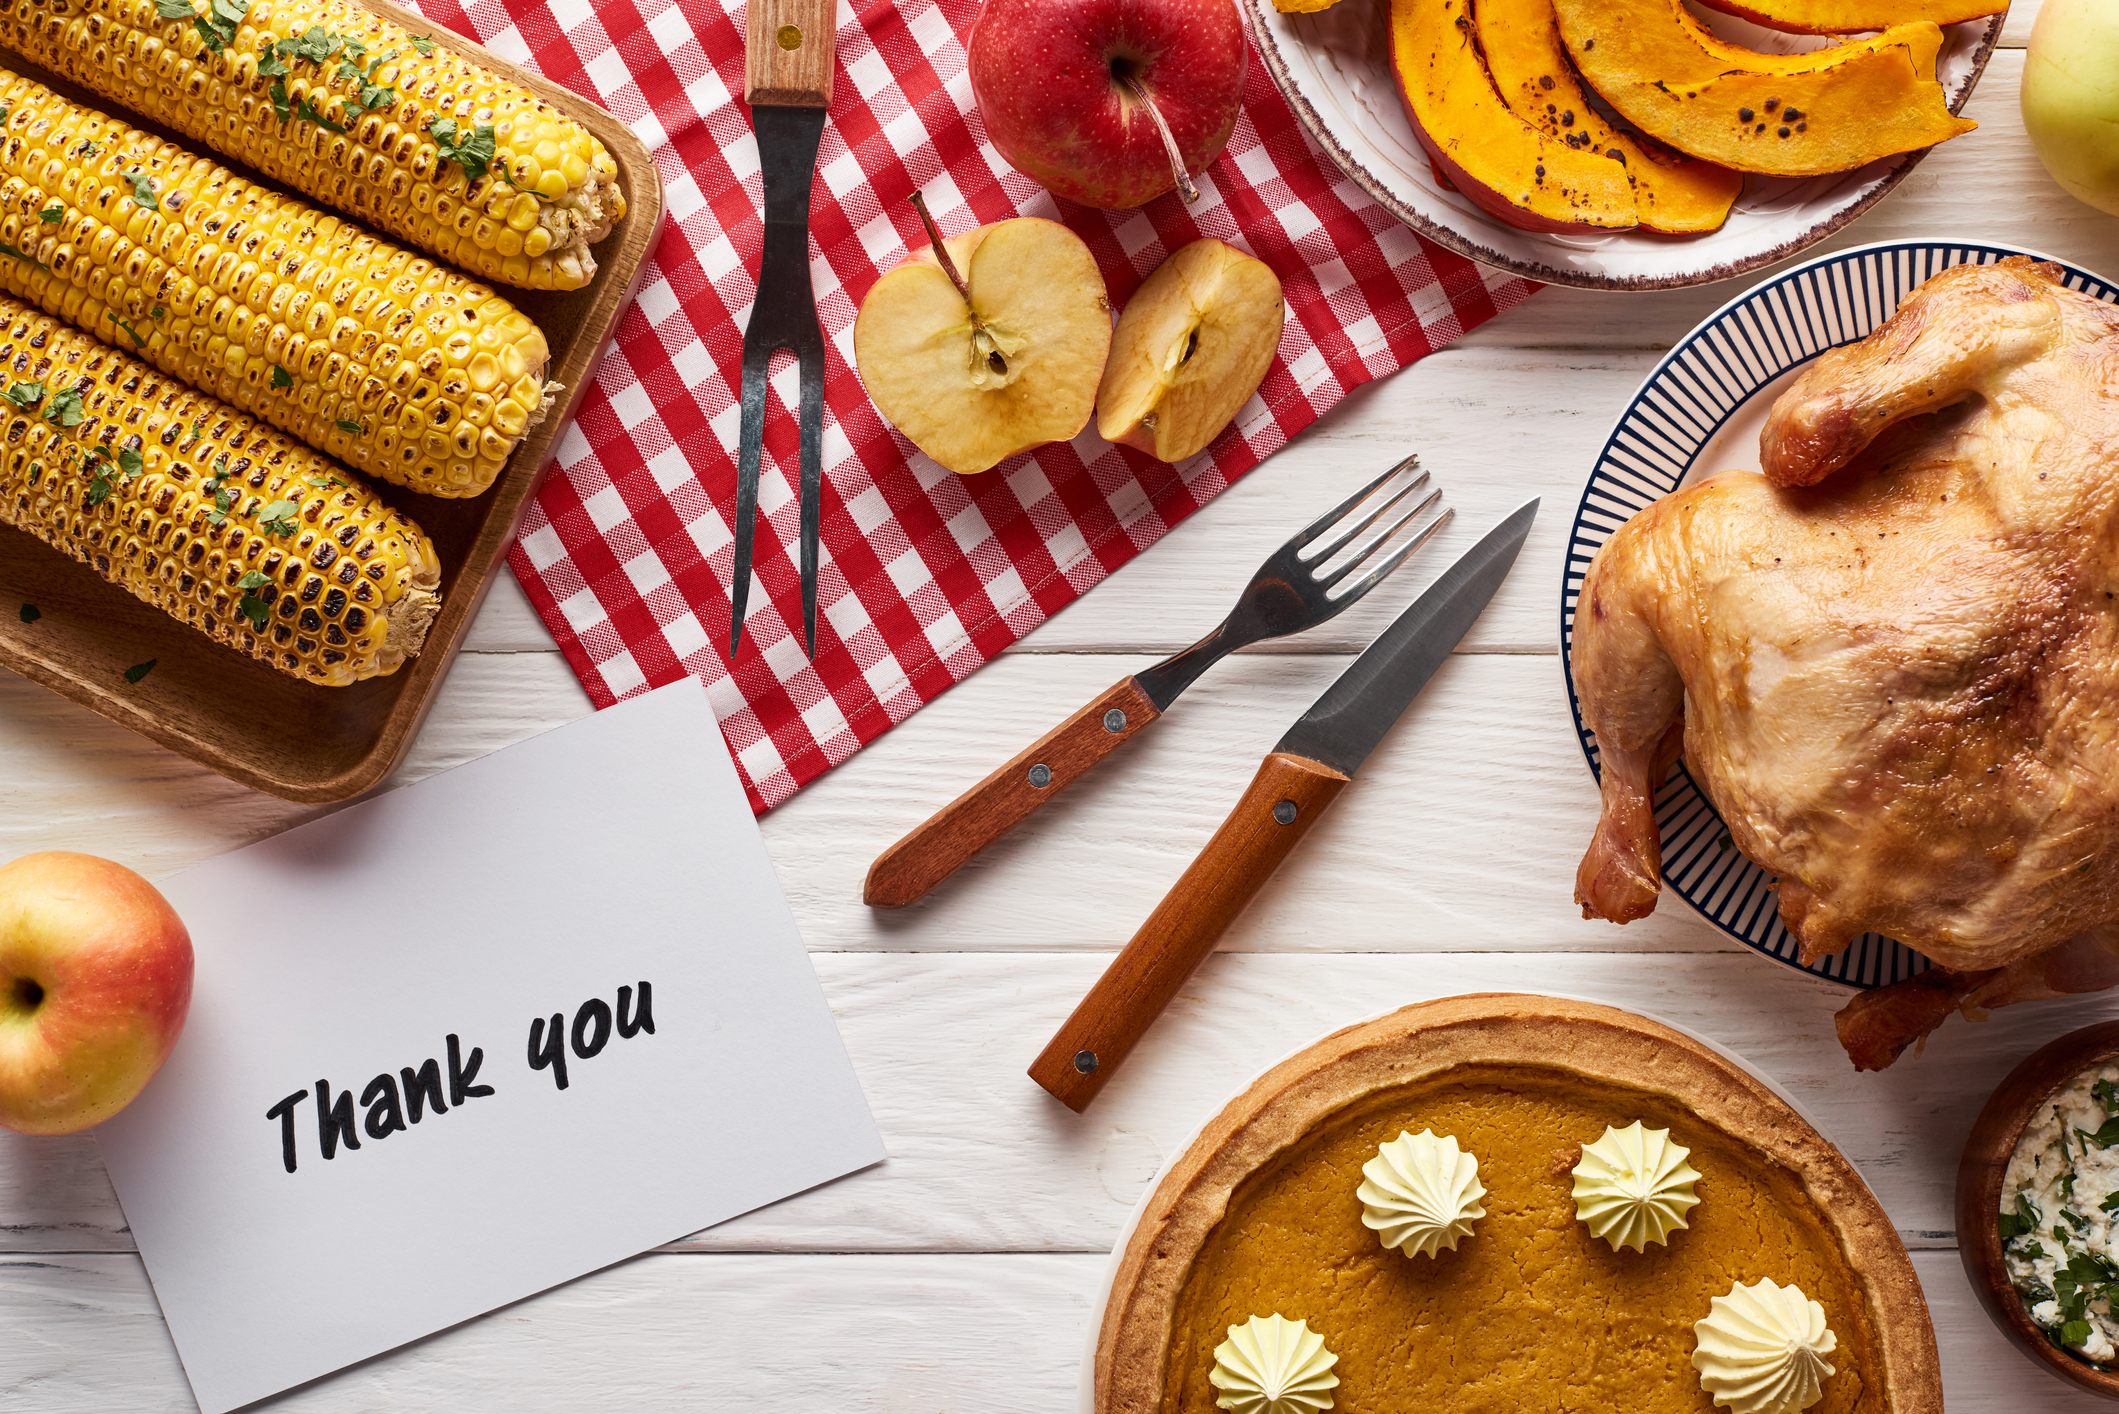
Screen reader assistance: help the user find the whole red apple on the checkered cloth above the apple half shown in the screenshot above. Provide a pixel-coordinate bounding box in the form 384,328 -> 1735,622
971,0 -> 1250,210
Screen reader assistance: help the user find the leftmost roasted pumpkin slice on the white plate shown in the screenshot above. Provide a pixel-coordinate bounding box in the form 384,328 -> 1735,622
1390,0 -> 1638,231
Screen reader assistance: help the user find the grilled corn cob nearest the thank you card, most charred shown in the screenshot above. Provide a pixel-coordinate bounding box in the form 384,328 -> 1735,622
0,297 -> 441,687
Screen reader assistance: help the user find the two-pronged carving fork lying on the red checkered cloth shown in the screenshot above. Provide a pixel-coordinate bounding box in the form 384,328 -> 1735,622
729,0 -> 833,659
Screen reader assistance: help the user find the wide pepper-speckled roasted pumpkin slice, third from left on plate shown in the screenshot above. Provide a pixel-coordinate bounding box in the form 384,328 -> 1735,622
1553,0 -> 1977,176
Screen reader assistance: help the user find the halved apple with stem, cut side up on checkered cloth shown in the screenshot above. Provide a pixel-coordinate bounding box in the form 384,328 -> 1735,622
854,197 -> 1110,475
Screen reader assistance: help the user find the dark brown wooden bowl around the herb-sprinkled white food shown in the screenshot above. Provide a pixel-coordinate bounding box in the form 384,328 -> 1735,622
1958,1022 -> 2119,1399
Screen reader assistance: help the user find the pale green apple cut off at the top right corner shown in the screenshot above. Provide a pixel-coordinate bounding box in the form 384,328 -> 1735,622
2022,0 -> 2119,216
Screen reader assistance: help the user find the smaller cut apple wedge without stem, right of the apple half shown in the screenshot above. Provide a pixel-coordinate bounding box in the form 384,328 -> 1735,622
1096,240 -> 1282,462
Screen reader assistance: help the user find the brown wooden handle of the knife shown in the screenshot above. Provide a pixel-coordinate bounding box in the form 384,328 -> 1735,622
1030,750 -> 1348,1113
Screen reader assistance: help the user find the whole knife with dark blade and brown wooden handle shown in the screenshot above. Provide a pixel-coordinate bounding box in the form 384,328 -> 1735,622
1030,498 -> 1538,1113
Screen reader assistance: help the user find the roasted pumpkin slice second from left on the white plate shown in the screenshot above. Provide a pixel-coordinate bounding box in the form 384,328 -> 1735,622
1473,0 -> 1744,233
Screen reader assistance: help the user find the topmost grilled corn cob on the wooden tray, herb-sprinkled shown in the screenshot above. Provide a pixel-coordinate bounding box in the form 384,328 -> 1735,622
0,0 -> 625,290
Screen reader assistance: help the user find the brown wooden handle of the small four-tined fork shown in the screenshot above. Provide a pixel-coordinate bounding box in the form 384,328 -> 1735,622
860,676 -> 1161,907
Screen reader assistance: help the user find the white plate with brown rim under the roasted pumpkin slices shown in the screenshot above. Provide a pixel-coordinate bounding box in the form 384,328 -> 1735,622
1244,0 -> 2007,290
